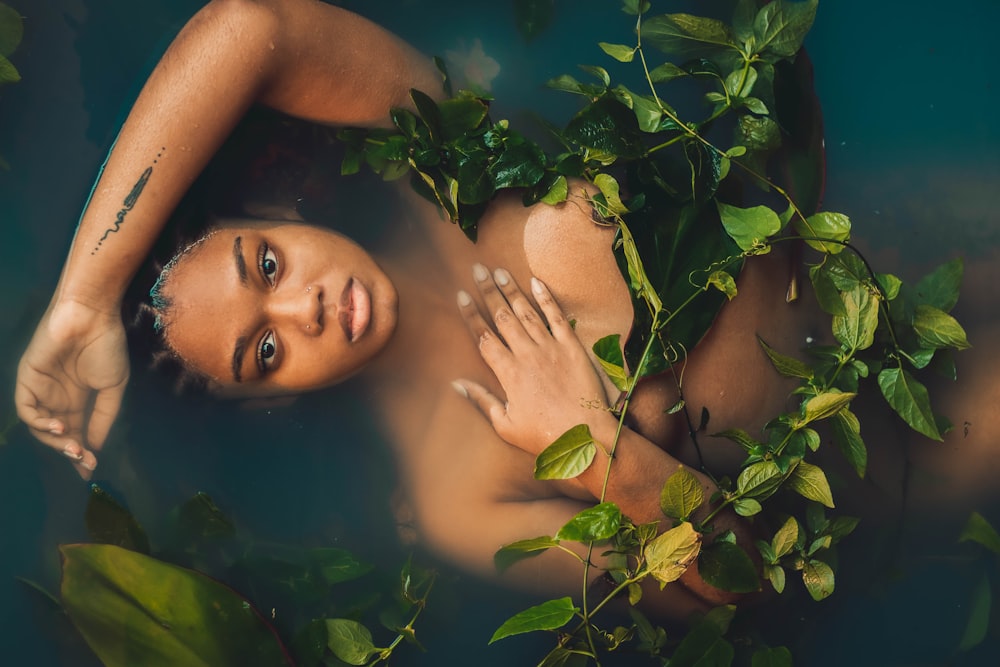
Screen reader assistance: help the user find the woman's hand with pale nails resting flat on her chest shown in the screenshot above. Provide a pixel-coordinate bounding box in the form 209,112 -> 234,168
455,264 -> 614,455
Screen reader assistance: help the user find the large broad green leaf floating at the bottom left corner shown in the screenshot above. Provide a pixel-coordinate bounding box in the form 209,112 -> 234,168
59,544 -> 291,667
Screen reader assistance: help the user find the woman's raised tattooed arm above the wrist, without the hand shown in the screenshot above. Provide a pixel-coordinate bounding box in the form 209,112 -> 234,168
55,0 -> 440,314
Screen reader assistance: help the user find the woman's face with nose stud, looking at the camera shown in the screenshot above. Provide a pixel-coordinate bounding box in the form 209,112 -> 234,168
160,220 -> 396,396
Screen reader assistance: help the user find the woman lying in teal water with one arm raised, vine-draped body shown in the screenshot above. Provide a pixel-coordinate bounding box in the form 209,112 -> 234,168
16,0 -> 828,615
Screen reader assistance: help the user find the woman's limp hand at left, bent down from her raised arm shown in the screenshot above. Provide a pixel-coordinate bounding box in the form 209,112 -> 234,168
14,302 -> 129,479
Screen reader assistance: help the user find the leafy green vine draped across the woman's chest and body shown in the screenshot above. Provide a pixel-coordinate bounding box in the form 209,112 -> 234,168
339,0 -> 968,665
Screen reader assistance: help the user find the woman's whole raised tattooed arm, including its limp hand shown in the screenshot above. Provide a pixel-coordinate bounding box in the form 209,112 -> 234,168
15,0 -> 441,477
